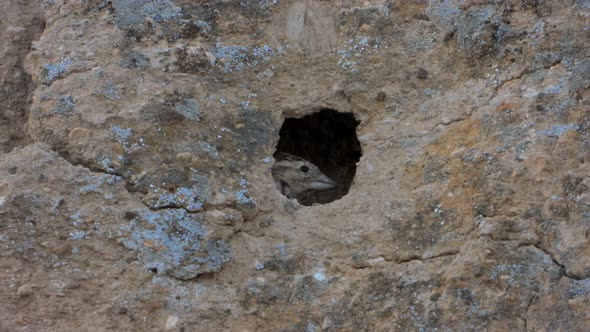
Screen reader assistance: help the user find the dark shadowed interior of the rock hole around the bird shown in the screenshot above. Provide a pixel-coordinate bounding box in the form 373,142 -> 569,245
274,109 -> 362,206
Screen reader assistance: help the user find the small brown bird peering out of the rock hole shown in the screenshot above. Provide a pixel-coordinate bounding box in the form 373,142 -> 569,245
271,152 -> 338,199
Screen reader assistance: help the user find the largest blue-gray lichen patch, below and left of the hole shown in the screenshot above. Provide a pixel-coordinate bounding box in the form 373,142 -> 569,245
121,209 -> 232,280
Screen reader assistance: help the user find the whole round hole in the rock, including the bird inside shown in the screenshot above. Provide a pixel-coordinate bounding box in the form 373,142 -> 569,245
272,109 -> 362,206
